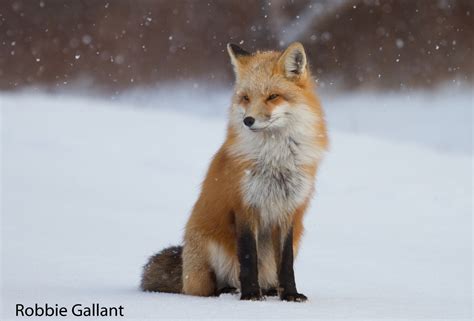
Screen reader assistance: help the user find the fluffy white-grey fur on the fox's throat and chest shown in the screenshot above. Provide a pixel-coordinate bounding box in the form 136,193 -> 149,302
230,106 -> 323,227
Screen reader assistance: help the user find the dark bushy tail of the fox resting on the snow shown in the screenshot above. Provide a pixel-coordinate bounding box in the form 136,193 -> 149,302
140,246 -> 183,293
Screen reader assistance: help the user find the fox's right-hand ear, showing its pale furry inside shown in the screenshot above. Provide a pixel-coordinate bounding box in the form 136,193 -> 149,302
278,42 -> 307,79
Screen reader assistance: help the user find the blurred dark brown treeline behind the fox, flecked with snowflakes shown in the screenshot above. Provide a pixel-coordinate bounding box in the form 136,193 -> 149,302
0,0 -> 474,91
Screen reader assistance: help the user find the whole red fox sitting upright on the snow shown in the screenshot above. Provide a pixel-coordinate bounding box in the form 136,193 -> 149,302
141,43 -> 328,302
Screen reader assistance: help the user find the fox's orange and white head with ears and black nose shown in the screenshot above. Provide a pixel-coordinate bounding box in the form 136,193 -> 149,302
227,42 -> 322,135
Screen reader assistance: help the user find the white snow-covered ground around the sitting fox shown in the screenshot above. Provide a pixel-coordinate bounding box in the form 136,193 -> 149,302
0,86 -> 473,320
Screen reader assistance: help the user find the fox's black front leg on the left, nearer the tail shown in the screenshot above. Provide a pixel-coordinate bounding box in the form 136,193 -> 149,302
238,229 -> 262,300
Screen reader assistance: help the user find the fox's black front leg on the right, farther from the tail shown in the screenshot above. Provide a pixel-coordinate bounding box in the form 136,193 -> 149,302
278,224 -> 308,302
